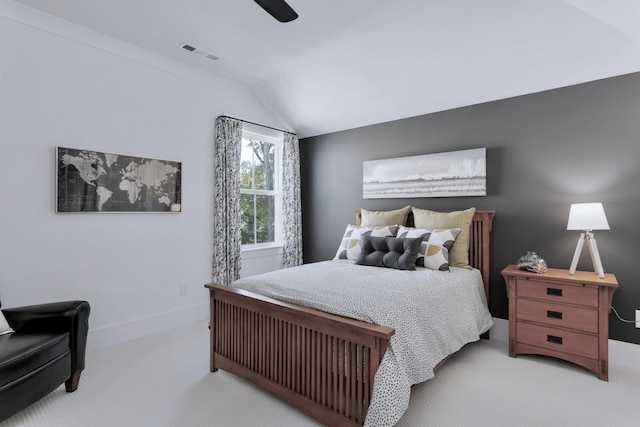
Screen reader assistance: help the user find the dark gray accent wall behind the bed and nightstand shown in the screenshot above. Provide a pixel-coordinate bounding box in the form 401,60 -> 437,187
300,73 -> 640,344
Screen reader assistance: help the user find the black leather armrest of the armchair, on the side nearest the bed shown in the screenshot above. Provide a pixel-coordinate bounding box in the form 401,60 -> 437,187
2,301 -> 91,373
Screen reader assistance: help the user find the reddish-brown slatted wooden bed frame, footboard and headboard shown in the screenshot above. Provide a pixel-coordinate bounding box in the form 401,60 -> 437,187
205,210 -> 494,426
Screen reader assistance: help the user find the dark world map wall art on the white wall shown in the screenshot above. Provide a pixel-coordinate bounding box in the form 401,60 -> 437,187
56,147 -> 182,212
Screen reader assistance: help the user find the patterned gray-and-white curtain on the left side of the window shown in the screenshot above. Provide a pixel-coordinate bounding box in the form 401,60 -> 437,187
211,117 -> 242,285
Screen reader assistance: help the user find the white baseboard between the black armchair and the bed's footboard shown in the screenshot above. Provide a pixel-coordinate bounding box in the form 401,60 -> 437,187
87,303 -> 209,352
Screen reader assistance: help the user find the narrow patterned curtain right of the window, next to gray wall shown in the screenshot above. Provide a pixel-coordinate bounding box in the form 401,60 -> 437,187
282,132 -> 302,268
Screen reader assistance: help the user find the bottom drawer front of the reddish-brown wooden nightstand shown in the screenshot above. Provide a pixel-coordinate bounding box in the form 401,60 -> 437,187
516,322 -> 598,359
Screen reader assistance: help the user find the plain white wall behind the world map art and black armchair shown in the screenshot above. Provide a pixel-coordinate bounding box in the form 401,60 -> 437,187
0,1 -> 279,350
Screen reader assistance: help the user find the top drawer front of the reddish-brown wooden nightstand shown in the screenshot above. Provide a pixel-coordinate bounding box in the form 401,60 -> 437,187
516,277 -> 598,307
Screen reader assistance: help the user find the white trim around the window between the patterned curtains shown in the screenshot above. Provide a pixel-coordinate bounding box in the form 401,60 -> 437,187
240,124 -> 284,251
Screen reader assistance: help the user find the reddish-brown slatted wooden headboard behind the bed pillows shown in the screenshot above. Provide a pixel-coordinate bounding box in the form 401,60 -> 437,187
354,210 -> 496,301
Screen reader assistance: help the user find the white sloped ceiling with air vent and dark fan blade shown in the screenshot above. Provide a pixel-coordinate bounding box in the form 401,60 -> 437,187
15,0 -> 640,137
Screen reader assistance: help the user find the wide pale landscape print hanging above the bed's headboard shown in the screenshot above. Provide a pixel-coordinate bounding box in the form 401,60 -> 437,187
362,148 -> 487,199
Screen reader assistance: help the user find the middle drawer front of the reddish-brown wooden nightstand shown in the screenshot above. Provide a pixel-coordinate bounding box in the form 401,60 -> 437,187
516,299 -> 598,334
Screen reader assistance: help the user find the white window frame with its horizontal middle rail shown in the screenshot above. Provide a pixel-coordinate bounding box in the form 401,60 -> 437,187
239,125 -> 284,252
